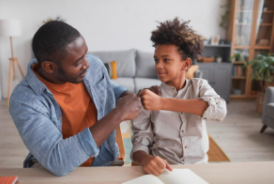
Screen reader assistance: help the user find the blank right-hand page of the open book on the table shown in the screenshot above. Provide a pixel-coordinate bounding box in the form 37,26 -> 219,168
158,169 -> 208,184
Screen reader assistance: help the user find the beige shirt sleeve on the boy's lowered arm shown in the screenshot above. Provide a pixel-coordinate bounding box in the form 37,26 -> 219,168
130,108 -> 154,161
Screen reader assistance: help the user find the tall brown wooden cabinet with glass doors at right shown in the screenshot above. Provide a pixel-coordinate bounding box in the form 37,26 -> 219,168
227,0 -> 274,99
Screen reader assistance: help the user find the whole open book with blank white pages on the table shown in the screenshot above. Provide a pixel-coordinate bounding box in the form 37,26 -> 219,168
122,169 -> 208,184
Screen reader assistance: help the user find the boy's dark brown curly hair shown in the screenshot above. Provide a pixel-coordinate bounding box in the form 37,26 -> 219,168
150,17 -> 204,61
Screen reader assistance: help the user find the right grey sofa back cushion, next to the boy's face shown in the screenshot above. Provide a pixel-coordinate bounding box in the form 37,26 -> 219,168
136,50 -> 158,79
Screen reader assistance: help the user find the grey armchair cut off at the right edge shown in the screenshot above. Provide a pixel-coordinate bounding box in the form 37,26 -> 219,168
261,87 -> 274,133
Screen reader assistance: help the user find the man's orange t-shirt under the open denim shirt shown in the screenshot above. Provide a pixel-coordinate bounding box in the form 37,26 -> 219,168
32,63 -> 97,166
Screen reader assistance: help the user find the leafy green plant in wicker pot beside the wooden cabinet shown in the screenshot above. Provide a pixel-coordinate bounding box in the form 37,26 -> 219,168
245,54 -> 274,114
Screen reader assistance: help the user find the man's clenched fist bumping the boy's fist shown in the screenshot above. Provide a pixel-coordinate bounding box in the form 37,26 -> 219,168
116,93 -> 142,121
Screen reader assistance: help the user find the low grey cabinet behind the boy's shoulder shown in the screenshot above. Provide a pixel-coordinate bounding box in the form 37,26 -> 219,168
198,63 -> 232,102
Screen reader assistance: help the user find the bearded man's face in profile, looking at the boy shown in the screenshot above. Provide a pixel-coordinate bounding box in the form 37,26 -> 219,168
57,36 -> 89,83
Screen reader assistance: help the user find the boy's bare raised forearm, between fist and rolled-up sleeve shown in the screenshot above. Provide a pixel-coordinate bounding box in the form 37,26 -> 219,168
161,98 -> 208,116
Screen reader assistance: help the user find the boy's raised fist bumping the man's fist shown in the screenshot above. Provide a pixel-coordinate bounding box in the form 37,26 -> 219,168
138,89 -> 163,111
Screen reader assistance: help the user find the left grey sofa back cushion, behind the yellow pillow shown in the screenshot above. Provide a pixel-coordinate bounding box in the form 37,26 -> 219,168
90,49 -> 136,78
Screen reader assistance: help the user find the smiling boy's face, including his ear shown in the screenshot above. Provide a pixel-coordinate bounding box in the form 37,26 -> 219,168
154,45 -> 191,83
